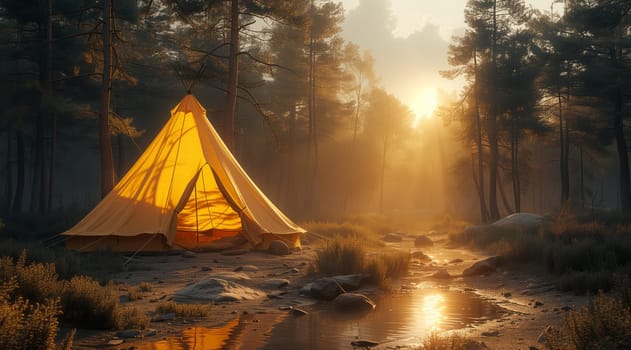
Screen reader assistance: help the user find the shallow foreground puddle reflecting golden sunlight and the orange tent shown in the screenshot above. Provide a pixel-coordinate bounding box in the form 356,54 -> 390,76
137,290 -> 502,350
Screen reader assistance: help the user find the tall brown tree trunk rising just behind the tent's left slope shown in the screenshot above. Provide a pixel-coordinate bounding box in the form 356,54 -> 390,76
99,0 -> 114,198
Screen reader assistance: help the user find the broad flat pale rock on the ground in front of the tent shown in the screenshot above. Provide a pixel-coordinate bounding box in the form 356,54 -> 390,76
173,278 -> 265,303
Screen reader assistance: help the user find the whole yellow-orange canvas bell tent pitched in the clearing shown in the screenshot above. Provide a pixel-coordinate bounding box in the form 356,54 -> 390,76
62,94 -> 305,251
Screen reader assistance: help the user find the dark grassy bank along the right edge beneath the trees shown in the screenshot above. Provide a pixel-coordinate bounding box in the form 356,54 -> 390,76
450,212 -> 631,293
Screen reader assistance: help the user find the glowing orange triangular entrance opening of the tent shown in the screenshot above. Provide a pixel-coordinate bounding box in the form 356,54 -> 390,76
175,164 -> 243,247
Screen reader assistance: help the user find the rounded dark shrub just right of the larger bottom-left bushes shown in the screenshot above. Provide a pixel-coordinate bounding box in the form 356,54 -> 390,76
62,276 -> 123,329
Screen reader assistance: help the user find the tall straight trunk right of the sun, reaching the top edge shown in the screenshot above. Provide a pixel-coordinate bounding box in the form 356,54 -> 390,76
487,0 -> 500,221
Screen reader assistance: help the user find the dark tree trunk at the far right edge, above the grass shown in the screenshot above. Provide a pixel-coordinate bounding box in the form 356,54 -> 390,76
613,87 -> 631,212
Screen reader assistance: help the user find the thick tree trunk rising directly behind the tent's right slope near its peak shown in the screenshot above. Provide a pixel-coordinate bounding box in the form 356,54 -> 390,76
223,0 -> 240,152
